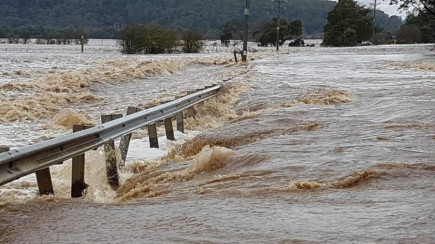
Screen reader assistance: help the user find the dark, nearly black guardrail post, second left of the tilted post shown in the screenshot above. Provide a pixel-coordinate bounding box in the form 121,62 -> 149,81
71,125 -> 89,197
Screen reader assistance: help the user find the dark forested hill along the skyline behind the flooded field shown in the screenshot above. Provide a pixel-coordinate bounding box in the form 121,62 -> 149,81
0,0 -> 336,36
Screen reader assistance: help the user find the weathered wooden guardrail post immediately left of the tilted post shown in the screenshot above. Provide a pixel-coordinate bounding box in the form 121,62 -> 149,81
101,114 -> 122,190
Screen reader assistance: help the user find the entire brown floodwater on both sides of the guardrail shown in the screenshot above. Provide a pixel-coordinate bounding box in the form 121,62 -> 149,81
0,41 -> 435,243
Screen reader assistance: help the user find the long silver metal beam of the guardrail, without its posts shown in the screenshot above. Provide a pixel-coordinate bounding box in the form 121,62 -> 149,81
0,85 -> 220,185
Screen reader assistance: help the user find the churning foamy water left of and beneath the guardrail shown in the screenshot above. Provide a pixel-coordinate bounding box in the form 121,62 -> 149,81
0,40 -> 268,204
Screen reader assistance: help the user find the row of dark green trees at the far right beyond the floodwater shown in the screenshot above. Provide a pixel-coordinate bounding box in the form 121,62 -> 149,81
322,0 -> 435,46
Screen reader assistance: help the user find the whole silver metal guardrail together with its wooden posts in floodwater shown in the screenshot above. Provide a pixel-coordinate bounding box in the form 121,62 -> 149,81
0,85 -> 220,197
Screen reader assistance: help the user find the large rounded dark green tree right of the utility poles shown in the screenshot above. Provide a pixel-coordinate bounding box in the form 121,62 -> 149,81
322,0 -> 373,46
